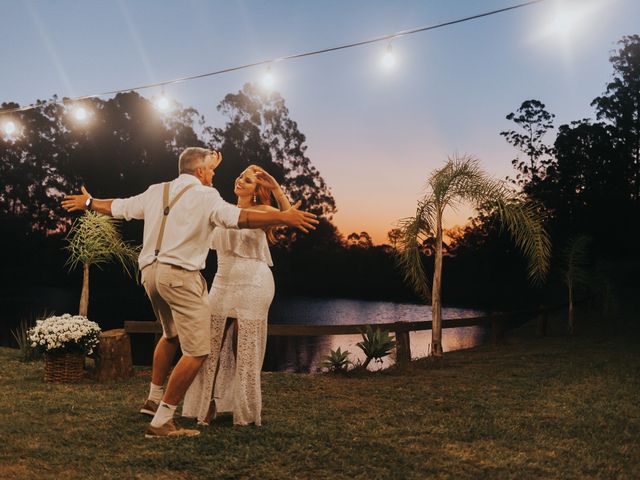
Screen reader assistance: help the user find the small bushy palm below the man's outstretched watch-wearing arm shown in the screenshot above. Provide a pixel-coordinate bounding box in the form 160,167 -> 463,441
65,211 -> 140,317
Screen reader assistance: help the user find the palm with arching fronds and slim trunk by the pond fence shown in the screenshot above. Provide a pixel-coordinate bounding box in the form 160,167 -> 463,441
396,155 -> 551,356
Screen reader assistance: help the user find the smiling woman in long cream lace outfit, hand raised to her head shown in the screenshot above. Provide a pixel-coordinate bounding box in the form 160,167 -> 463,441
182,165 -> 291,426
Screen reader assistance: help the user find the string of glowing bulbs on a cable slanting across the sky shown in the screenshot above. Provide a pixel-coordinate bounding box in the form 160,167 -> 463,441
0,0 -> 545,122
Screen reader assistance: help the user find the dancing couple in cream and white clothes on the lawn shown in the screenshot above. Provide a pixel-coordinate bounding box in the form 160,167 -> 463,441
62,147 -> 318,438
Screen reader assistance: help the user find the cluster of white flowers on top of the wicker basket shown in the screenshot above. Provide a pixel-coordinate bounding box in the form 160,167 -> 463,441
28,313 -> 100,355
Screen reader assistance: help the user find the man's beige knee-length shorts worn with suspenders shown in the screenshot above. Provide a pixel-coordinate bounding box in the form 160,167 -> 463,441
142,261 -> 211,357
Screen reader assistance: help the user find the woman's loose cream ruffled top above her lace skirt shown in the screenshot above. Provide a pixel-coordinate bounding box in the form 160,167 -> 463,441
211,227 -> 273,267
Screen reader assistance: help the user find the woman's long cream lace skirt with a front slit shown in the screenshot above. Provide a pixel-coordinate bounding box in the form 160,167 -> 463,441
182,255 -> 275,425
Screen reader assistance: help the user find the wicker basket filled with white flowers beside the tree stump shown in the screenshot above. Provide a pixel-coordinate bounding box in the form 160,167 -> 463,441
28,313 -> 100,383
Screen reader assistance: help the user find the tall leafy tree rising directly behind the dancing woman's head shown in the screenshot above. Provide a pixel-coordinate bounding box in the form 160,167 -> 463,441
209,83 -> 336,220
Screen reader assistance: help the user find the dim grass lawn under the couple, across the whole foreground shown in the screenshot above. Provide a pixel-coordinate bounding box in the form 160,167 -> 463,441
0,316 -> 640,480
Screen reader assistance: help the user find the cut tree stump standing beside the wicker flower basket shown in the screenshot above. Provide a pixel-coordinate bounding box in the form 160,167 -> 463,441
95,328 -> 133,382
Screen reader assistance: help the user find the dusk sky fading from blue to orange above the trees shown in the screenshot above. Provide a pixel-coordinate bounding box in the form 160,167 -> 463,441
0,0 -> 640,243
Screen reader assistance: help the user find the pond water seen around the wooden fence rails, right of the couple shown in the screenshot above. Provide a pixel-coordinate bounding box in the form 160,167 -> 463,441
263,298 -> 488,373
